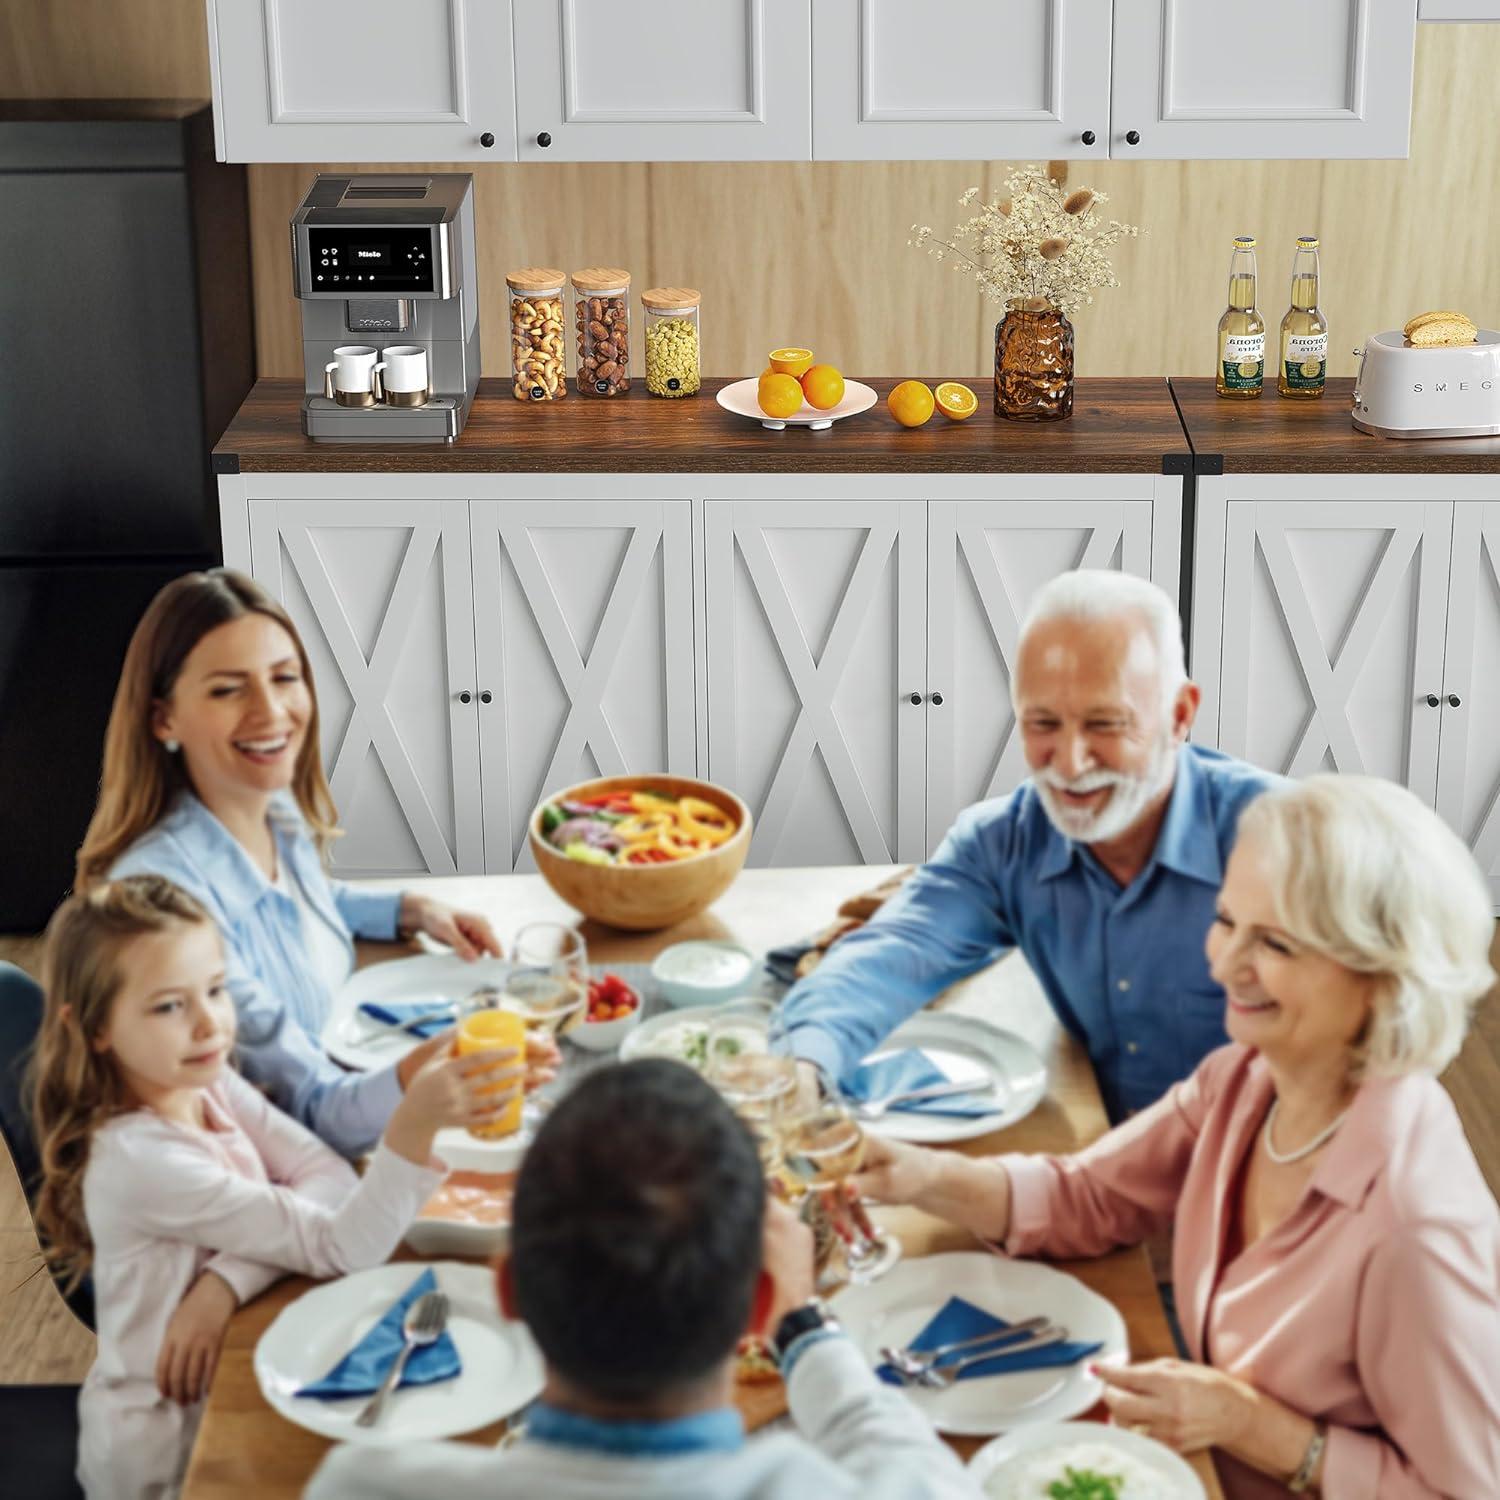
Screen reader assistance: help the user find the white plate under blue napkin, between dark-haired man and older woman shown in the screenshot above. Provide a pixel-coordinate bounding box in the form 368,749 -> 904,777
834,1251 -> 1130,1437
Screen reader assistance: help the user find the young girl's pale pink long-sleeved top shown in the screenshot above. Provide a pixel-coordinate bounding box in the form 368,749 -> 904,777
78,1073 -> 443,1500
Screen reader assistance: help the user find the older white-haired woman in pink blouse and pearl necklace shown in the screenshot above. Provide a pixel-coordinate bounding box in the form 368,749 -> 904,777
861,776 -> 1500,1500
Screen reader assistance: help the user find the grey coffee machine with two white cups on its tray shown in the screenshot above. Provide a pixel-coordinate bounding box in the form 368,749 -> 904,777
291,173 -> 479,443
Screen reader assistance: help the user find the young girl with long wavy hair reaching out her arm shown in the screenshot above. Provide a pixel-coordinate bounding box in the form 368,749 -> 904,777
35,876 -> 521,1500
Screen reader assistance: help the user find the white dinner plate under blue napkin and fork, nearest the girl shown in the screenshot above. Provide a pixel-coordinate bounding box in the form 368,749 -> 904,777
255,1260 -> 543,1443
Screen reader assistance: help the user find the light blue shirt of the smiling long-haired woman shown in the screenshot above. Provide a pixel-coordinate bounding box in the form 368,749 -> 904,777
110,792 -> 401,1155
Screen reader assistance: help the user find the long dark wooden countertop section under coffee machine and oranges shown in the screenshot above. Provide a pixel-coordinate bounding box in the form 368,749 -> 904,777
213,375 -> 1190,474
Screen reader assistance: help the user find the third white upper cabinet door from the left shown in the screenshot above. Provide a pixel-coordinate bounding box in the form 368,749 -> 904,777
813,0 -> 1110,161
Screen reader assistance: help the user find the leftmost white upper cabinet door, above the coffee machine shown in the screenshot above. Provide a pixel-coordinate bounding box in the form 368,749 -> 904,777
209,0 -> 516,162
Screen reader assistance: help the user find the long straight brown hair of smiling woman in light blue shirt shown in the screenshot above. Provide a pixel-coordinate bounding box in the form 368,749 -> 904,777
74,567 -> 339,891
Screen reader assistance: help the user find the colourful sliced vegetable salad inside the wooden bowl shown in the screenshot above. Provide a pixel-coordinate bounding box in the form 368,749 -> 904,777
542,789 -> 740,866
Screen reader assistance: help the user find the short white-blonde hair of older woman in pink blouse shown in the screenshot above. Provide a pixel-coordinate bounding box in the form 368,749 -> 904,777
1238,776 -> 1496,1080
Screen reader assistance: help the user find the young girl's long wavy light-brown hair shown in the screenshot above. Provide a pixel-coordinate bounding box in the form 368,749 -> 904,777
30,875 -> 213,1289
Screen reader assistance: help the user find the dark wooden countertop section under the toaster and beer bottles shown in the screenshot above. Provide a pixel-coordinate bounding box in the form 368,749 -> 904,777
1172,375 -> 1500,474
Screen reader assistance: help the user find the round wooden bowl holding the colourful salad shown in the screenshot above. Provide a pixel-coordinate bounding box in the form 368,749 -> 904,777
530,776 -> 752,932
